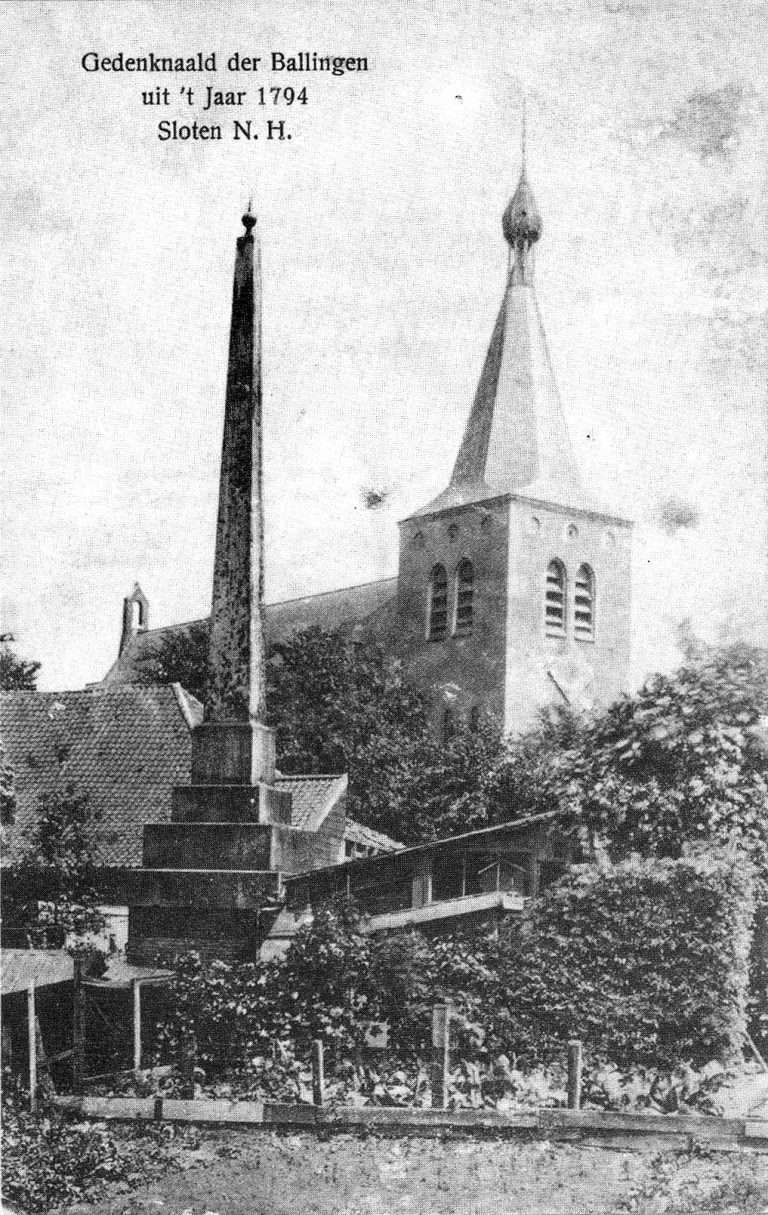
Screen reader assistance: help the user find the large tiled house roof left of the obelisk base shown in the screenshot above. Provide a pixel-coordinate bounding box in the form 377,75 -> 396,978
0,684 -> 202,865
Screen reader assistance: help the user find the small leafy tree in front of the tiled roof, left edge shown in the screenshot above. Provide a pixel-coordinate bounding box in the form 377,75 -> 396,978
2,784 -> 103,948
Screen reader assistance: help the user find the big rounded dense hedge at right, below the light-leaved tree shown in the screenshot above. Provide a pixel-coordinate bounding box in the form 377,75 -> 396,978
498,852 -> 753,1069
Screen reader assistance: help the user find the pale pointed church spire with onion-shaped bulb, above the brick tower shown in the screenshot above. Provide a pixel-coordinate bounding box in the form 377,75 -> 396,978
425,126 -> 587,510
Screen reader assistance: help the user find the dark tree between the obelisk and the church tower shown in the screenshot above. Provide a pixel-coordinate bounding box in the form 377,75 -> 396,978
267,628 -> 501,843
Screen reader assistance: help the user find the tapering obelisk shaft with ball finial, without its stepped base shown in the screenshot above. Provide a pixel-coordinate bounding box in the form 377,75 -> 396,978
205,205 -> 266,724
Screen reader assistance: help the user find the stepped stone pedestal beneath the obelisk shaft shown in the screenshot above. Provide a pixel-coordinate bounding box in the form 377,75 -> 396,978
128,722 -> 301,965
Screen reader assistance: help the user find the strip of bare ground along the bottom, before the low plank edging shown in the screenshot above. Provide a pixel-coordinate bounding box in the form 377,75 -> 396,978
44,1126 -> 768,1215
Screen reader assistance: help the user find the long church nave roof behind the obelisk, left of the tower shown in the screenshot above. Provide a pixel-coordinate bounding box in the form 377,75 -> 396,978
103,578 -> 397,685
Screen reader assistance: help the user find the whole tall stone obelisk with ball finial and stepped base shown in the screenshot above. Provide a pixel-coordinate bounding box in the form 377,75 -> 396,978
128,213 -> 294,962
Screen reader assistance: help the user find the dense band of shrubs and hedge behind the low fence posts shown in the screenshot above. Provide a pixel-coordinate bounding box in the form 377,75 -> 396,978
160,855 -> 752,1103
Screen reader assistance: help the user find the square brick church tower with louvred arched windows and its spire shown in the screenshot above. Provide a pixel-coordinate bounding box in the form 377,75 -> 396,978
397,151 -> 632,734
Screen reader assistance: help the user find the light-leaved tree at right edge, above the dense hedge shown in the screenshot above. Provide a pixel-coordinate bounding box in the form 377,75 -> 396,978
490,645 -> 768,881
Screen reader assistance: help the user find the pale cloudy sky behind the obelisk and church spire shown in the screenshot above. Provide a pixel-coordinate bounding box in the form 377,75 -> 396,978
0,0 -> 768,689
